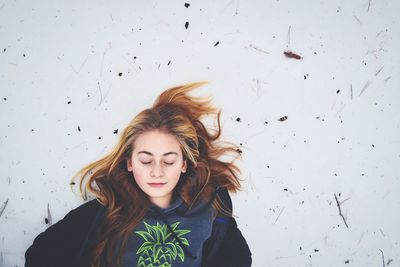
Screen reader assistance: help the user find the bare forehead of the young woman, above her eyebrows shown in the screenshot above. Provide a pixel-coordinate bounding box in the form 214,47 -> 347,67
133,130 -> 181,155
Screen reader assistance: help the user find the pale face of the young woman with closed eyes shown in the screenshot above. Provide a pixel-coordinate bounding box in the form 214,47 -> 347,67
127,130 -> 186,208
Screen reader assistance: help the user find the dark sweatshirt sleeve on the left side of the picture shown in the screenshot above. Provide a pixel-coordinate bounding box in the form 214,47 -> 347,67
25,200 -> 99,267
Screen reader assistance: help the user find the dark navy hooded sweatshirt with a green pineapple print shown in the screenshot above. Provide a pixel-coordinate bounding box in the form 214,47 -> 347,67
25,189 -> 252,267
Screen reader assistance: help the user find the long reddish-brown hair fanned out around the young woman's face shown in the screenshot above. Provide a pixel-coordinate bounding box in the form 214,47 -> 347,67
72,82 -> 240,267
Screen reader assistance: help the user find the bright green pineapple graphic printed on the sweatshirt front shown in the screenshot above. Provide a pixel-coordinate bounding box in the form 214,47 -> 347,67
135,222 -> 191,267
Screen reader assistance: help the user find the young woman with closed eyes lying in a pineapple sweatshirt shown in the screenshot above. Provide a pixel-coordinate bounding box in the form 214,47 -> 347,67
25,83 -> 252,267
